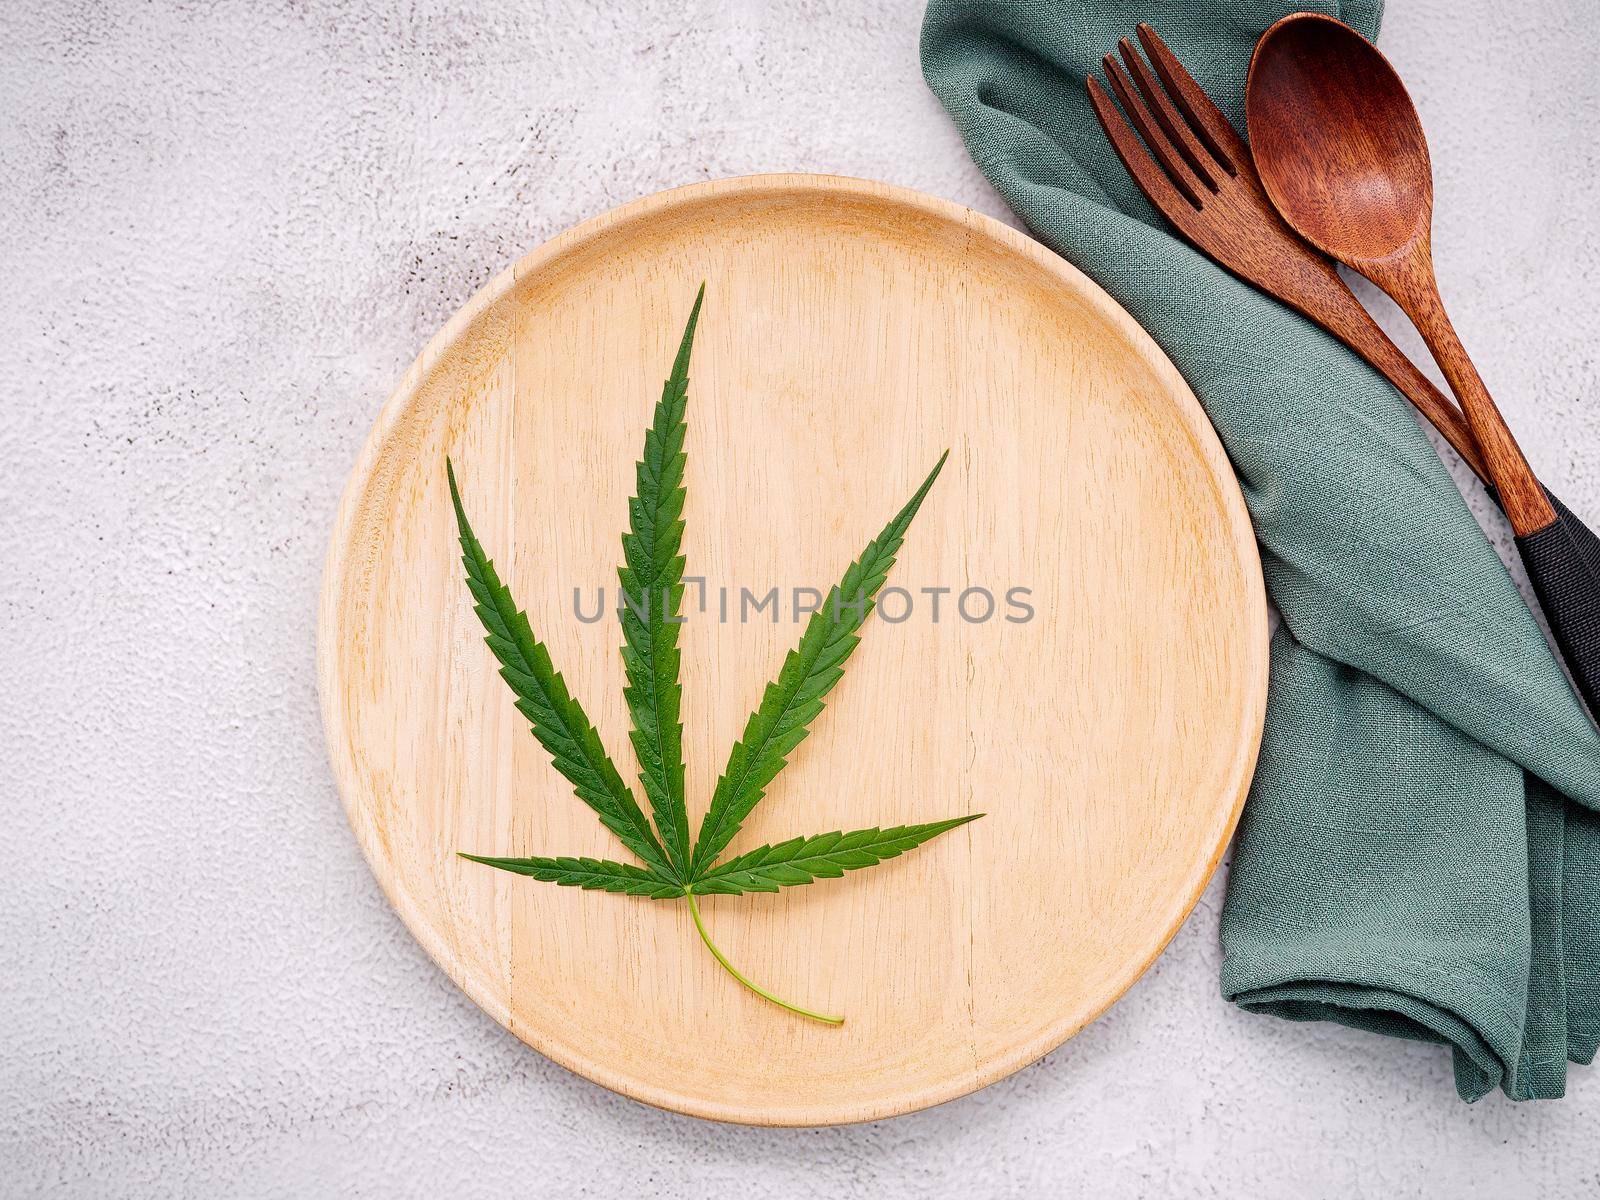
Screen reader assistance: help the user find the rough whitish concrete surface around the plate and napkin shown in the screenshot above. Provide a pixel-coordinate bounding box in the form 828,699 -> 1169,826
0,0 -> 1600,1200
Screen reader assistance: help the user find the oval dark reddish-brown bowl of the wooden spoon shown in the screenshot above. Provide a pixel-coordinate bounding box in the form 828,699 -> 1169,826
1245,13 -> 1434,266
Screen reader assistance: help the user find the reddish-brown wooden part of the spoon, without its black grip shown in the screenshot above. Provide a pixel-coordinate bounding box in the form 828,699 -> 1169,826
1245,13 -> 1555,536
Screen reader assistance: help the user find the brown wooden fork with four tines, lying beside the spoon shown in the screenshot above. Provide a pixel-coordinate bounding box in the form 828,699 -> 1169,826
1088,24 -> 1486,478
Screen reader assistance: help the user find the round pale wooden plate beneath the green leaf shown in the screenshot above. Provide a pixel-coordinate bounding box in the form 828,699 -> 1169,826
318,176 -> 1267,1125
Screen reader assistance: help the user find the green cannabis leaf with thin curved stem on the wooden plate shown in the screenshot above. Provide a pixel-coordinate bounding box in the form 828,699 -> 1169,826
445,285 -> 982,1026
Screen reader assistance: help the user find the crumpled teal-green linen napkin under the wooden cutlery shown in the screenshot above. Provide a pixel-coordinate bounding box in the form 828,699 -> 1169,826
922,0 -> 1600,1099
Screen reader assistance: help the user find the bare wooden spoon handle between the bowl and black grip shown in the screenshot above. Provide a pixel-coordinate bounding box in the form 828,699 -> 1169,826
1366,238 -> 1555,538
